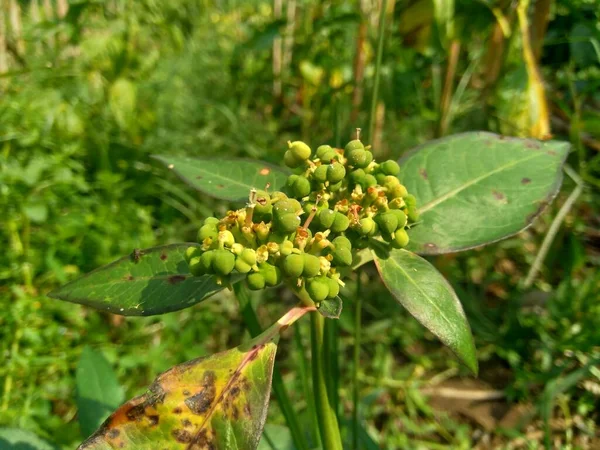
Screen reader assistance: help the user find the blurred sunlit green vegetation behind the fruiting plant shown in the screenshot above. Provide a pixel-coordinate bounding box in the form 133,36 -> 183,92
0,0 -> 600,449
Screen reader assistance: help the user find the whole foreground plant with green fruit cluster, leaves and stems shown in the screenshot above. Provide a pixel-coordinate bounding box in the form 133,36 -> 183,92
51,132 -> 569,450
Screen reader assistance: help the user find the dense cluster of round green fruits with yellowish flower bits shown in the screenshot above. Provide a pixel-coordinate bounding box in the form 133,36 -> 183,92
186,134 -> 418,303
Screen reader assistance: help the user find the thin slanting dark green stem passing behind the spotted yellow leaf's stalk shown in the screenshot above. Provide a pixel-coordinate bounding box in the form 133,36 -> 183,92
233,283 -> 309,450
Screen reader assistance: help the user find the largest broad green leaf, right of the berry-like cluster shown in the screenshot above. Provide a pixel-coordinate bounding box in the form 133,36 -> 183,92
400,132 -> 569,255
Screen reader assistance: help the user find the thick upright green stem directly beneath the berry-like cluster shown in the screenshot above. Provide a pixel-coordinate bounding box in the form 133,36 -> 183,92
310,312 -> 342,450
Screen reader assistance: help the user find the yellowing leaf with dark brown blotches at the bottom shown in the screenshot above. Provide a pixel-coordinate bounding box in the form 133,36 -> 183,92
79,336 -> 277,450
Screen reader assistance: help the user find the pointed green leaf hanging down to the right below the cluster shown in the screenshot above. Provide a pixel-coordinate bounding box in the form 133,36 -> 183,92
375,250 -> 477,374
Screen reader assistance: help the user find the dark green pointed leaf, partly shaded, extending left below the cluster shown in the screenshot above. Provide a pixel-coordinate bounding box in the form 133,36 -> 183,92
48,243 -> 223,316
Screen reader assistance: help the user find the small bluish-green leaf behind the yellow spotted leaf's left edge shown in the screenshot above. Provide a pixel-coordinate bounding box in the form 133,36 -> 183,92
75,347 -> 125,437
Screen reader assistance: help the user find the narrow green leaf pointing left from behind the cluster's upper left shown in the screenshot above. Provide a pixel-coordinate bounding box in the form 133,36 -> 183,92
153,155 -> 288,201
